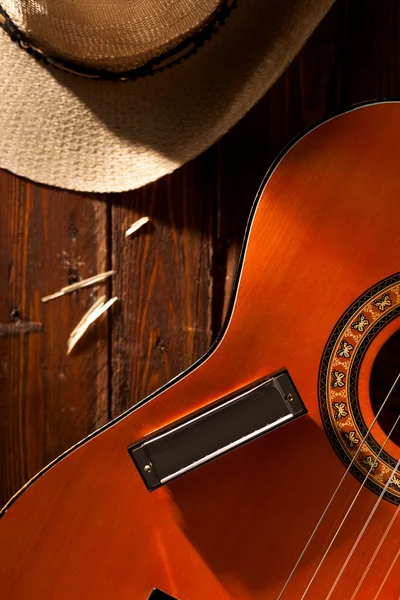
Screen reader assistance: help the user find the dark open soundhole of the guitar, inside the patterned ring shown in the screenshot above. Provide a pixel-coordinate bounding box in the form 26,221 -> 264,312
370,330 -> 400,447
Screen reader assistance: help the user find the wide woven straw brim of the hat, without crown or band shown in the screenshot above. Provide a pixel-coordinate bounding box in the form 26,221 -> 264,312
0,0 -> 333,192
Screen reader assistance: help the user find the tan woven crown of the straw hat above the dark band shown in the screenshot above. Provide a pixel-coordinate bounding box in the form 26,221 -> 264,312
1,0 -> 219,71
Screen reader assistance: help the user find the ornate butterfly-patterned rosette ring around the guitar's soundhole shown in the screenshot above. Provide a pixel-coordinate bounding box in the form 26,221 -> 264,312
319,273 -> 400,504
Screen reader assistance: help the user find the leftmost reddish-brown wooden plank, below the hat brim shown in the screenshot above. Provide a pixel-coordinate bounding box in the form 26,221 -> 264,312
0,172 -> 108,504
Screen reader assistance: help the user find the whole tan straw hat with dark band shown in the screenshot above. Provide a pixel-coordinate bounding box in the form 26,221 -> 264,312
0,0 -> 333,192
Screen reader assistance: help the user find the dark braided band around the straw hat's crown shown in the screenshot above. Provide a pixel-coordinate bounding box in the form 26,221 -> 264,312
0,0 -> 237,81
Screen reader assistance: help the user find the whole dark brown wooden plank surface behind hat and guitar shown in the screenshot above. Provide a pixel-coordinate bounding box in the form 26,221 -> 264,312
0,0 -> 400,504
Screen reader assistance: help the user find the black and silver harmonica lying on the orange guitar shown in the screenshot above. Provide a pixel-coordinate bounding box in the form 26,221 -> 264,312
128,371 -> 307,491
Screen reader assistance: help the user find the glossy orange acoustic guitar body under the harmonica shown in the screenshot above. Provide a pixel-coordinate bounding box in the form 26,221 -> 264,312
0,102 -> 400,600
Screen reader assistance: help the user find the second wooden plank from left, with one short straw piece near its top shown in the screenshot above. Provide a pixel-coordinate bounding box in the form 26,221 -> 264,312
111,155 -> 216,416
